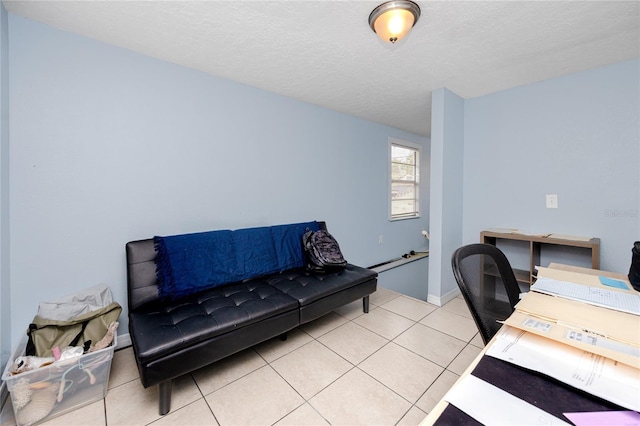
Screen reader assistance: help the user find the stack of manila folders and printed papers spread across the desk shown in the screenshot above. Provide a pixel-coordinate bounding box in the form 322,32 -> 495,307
496,268 -> 640,411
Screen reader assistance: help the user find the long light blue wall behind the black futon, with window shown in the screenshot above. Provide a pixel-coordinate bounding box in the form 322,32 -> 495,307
2,14 -> 429,350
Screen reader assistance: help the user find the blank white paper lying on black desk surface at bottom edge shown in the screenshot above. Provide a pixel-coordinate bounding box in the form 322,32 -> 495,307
444,375 -> 571,426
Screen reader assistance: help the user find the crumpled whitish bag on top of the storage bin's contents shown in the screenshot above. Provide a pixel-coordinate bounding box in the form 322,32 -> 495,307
38,284 -> 113,321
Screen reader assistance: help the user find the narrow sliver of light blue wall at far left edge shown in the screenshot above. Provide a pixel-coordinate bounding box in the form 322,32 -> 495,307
0,4 -> 11,374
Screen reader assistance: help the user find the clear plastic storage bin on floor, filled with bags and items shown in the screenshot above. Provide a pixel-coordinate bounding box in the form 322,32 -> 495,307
2,336 -> 117,426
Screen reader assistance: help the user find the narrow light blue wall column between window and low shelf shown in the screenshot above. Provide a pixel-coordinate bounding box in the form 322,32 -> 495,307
427,89 -> 464,305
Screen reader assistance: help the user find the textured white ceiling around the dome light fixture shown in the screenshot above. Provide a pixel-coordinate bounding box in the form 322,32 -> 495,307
3,0 -> 640,136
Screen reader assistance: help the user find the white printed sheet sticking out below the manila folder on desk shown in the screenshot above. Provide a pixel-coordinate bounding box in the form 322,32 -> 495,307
487,326 -> 640,411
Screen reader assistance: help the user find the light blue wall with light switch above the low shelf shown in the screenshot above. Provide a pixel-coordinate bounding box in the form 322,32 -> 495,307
463,60 -> 640,272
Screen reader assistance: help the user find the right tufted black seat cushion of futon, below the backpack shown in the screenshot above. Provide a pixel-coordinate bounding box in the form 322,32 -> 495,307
266,264 -> 378,307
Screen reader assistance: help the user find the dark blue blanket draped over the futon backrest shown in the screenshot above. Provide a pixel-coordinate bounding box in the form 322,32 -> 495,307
153,221 -> 320,300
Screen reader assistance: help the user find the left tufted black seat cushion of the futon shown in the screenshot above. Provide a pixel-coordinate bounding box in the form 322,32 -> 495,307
129,280 -> 299,362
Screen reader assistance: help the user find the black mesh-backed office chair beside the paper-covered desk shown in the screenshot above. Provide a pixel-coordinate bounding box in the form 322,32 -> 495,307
451,244 -> 520,344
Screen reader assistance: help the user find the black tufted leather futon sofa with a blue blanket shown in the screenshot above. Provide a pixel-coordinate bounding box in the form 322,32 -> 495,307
126,222 -> 377,415
